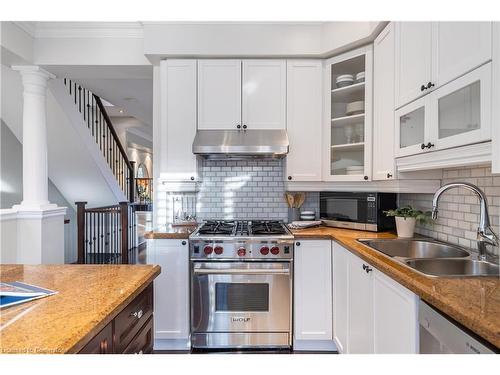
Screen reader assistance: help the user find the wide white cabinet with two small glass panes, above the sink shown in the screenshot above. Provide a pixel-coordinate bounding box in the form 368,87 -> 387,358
395,63 -> 492,157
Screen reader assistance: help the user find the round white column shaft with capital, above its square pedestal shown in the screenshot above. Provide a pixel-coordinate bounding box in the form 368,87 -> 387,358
12,65 -> 55,210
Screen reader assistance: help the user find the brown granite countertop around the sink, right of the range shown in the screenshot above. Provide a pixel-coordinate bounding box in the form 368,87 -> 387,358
292,227 -> 500,348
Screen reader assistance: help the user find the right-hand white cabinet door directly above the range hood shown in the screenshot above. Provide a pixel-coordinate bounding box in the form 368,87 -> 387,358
241,60 -> 286,129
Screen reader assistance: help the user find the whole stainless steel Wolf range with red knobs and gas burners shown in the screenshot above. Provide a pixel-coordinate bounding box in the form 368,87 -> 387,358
189,220 -> 294,349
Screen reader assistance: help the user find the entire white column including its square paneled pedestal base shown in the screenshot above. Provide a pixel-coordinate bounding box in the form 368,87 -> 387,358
12,65 -> 66,264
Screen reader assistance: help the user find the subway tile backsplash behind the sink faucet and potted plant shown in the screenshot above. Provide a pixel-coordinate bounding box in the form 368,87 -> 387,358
399,166 -> 500,255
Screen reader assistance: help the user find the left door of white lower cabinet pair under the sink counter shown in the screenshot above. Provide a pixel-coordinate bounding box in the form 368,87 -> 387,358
347,255 -> 373,354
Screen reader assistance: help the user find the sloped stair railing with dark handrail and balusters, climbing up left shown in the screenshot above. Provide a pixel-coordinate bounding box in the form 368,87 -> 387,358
64,78 -> 135,202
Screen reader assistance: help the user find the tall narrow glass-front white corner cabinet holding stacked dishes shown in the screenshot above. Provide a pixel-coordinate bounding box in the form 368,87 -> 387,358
323,46 -> 373,181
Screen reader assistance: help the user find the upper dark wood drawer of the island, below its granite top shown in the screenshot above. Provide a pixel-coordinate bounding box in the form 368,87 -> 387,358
115,284 -> 153,353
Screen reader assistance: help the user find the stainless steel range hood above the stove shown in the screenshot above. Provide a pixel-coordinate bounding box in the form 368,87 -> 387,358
193,129 -> 289,159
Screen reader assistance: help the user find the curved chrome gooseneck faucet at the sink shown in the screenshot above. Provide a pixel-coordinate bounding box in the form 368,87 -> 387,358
432,182 -> 499,260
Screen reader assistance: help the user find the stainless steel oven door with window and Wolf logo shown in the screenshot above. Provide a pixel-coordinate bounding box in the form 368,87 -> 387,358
191,262 -> 292,334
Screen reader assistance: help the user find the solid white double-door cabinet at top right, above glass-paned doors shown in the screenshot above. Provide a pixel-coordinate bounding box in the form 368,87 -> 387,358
395,22 -> 492,108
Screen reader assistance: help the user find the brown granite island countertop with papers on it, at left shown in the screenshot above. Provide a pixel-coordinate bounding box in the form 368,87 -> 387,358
0,264 -> 160,354
